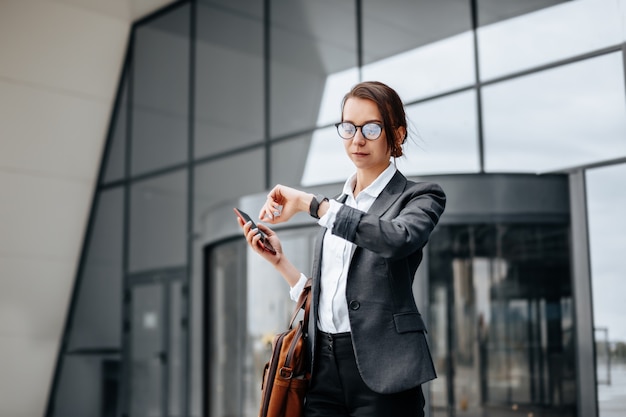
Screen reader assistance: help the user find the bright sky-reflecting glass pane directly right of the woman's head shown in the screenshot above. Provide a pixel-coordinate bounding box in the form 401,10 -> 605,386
396,90 -> 479,175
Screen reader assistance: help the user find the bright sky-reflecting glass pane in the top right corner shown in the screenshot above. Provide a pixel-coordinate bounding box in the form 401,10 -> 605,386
478,0 -> 626,80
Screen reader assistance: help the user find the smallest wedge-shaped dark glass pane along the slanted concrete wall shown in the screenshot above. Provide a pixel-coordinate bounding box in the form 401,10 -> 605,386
102,74 -> 128,183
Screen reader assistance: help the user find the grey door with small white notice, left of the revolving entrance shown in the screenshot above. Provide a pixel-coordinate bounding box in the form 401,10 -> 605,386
126,271 -> 186,417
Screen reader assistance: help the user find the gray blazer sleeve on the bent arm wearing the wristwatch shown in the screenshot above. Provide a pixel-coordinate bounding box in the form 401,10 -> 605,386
332,182 -> 446,259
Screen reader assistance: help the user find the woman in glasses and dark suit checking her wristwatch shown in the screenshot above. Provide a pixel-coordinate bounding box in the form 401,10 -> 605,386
240,82 -> 445,417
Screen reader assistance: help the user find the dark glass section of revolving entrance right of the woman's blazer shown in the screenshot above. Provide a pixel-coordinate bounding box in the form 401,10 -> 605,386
428,224 -> 576,417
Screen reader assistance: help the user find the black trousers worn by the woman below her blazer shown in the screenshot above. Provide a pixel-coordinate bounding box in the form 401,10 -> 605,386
304,332 -> 424,417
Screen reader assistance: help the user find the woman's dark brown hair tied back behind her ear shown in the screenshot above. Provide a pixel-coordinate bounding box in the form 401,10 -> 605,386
341,81 -> 408,158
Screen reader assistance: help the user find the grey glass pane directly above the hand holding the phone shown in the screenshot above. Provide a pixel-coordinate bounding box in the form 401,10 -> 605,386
194,148 -> 265,230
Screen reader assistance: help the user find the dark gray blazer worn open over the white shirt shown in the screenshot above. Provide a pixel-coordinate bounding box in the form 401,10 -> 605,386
308,172 -> 446,394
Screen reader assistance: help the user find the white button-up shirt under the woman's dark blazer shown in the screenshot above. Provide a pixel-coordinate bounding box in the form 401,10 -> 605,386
290,163 -> 396,333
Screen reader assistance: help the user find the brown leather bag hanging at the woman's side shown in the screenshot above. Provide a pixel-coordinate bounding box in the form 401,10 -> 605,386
259,279 -> 311,417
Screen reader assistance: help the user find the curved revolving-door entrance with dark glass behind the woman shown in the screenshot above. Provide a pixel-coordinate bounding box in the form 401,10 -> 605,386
203,174 -> 580,417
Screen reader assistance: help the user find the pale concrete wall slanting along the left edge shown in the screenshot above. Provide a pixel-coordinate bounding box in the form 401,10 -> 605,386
0,0 -> 171,417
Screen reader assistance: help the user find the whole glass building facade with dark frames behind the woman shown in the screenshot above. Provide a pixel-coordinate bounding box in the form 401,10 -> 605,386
46,0 -> 626,417
